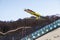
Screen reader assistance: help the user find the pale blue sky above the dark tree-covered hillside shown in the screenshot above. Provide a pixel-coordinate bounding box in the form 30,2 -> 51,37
0,0 -> 60,21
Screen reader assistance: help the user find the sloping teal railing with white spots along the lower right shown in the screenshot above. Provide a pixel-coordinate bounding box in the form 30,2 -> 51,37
21,19 -> 60,40
